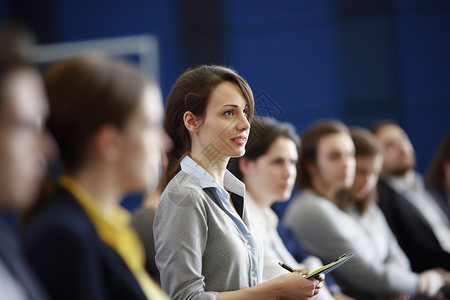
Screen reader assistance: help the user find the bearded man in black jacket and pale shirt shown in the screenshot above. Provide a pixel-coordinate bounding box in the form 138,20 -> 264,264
371,121 -> 450,272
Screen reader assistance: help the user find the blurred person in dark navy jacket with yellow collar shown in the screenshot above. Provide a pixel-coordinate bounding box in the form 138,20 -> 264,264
24,55 -> 168,300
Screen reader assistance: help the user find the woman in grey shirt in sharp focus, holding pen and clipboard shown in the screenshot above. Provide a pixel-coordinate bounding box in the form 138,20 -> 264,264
154,66 -> 323,300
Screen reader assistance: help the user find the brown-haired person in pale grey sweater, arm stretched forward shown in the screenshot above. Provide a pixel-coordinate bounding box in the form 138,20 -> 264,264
283,121 -> 443,300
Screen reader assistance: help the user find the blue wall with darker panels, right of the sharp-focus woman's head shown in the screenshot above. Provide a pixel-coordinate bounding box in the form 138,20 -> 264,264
225,0 -> 450,172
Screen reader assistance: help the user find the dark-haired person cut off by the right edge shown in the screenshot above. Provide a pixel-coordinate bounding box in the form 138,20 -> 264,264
424,132 -> 450,219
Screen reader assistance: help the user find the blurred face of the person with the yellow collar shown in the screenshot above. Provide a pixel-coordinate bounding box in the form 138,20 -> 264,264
119,86 -> 169,191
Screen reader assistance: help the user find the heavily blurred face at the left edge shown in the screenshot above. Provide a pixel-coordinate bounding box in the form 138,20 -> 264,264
0,69 -> 51,208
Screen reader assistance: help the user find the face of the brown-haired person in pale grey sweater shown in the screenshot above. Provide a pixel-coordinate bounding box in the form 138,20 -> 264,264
314,133 -> 355,192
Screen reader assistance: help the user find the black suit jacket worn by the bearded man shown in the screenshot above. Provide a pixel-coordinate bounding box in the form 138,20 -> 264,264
378,180 -> 450,272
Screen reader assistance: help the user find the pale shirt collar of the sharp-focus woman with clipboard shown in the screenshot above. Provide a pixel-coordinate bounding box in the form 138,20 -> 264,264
180,155 -> 245,199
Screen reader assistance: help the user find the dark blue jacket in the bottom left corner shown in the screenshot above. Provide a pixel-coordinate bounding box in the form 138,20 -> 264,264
0,218 -> 48,300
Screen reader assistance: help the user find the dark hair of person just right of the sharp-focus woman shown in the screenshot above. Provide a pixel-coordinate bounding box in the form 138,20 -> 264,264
227,116 -> 300,180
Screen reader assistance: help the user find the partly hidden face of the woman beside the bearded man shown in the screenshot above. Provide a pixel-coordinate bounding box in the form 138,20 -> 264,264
351,155 -> 383,201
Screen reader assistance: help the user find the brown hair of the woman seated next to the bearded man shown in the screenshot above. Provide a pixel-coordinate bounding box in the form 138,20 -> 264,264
338,127 -> 382,215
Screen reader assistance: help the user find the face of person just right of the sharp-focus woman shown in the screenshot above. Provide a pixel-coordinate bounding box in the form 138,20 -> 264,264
242,137 -> 298,206
